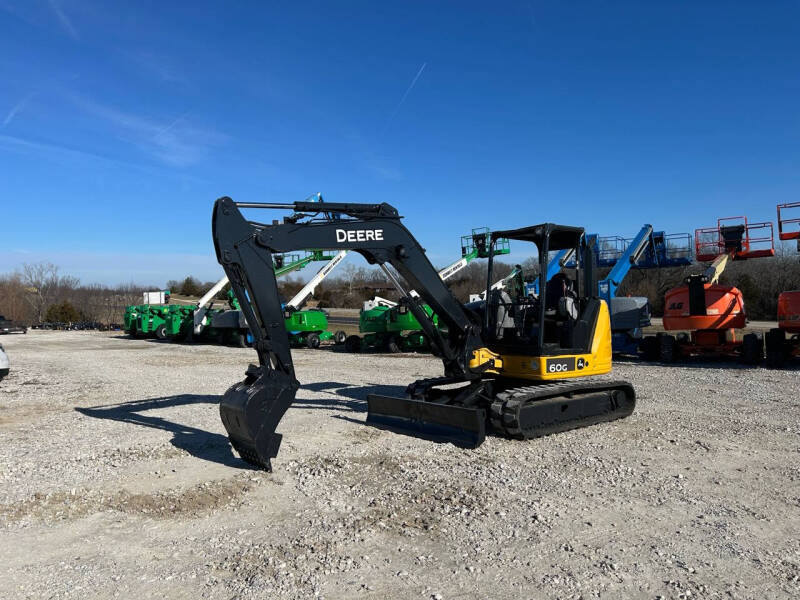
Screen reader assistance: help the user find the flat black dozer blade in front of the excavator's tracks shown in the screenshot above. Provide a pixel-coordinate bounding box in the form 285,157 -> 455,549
367,394 -> 486,448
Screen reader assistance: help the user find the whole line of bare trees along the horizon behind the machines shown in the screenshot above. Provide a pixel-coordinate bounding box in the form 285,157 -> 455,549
0,246 -> 800,325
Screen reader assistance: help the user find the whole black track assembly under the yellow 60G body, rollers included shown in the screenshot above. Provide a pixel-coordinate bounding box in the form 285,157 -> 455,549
489,380 -> 636,440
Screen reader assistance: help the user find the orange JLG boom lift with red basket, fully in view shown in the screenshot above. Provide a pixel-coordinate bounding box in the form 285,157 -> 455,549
659,217 -> 775,364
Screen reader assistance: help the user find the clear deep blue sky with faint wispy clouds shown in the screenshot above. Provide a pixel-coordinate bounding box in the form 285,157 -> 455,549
0,0 -> 800,285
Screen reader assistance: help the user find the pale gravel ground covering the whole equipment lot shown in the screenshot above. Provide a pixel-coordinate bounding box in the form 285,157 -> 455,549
0,331 -> 800,599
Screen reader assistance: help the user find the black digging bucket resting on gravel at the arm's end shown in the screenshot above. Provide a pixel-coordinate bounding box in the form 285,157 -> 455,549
219,365 -> 300,471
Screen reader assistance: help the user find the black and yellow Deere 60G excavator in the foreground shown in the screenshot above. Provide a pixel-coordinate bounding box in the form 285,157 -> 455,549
212,197 -> 636,470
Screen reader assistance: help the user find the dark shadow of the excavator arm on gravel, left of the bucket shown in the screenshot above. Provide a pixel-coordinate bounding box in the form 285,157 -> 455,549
75,394 -> 253,469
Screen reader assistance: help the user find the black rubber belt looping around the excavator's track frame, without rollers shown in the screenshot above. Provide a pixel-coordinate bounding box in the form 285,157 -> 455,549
489,380 -> 635,439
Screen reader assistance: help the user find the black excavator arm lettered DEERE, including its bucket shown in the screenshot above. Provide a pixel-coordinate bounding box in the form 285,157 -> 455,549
212,197 -> 481,469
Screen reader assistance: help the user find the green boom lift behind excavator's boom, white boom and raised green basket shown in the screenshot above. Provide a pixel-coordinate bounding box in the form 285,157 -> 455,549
345,227 -> 511,352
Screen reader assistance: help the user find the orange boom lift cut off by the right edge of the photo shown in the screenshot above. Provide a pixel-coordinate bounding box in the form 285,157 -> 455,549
766,202 -> 800,367
